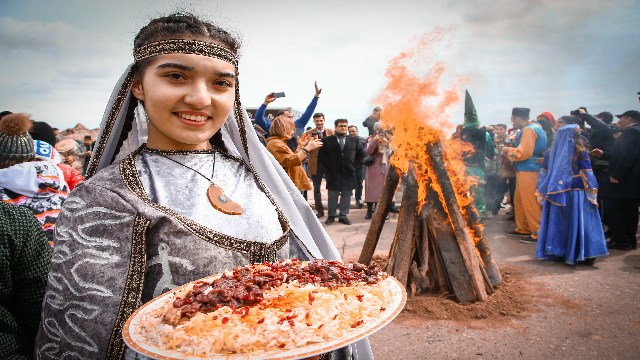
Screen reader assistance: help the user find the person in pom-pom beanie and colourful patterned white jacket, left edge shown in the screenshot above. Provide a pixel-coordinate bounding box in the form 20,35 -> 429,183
0,114 -> 69,246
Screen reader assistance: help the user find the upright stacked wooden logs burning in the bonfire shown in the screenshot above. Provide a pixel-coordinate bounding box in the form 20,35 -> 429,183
358,142 -> 501,304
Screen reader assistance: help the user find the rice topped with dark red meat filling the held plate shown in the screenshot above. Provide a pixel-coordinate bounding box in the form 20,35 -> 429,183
138,260 -> 393,356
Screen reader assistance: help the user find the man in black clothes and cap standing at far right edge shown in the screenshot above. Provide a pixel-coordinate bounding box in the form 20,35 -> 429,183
592,110 -> 640,250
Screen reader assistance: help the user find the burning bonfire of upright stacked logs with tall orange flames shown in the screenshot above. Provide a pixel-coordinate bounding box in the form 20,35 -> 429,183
359,30 -> 501,303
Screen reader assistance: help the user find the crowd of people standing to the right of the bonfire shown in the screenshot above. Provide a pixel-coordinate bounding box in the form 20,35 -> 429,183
453,92 -> 640,264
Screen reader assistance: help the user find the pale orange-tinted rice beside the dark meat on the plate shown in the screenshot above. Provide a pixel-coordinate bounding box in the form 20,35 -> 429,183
141,262 -> 393,357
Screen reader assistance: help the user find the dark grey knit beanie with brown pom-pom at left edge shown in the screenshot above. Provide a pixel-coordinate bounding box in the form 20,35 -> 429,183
0,114 -> 36,168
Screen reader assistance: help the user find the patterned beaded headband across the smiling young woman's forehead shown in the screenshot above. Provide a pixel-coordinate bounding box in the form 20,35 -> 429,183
133,39 -> 238,69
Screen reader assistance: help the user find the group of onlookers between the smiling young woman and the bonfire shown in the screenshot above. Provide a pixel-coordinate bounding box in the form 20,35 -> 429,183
254,94 -> 399,225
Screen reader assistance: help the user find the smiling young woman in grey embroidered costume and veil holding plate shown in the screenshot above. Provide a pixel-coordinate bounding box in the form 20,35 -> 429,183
35,14 -> 372,359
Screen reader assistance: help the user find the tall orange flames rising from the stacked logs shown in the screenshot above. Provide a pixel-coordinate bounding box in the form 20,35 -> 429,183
374,29 -> 478,241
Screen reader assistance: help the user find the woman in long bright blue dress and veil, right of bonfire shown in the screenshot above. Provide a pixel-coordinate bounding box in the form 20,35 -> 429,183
536,116 -> 609,265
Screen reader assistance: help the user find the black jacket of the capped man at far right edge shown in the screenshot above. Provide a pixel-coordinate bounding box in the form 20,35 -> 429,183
602,124 -> 640,199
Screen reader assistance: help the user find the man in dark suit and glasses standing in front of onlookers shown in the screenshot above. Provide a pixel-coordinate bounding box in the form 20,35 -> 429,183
318,119 -> 364,225
